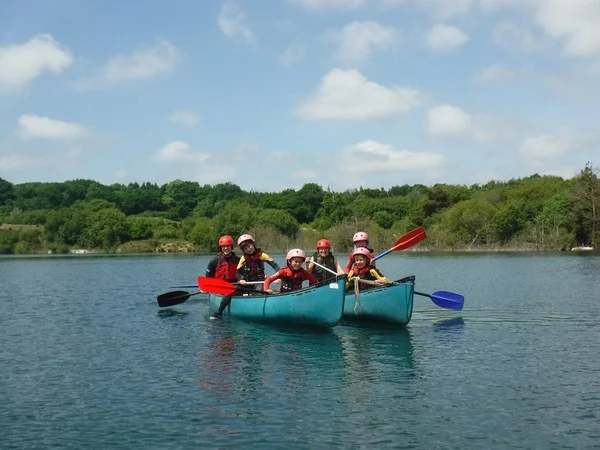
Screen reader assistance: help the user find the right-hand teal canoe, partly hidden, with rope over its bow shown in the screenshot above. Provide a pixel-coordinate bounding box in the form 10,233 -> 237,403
343,275 -> 415,325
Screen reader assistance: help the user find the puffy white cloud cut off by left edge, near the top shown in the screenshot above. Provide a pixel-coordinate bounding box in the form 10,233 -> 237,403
0,34 -> 73,94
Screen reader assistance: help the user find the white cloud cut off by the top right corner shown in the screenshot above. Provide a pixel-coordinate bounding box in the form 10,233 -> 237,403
536,0 -> 600,56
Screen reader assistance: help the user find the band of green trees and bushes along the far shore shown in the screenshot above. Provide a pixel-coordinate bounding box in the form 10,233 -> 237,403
0,163 -> 600,254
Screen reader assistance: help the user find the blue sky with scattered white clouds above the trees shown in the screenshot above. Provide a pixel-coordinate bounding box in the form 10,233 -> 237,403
0,0 -> 600,192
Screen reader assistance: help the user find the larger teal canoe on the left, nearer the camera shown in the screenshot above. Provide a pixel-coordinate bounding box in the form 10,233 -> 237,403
209,277 -> 347,327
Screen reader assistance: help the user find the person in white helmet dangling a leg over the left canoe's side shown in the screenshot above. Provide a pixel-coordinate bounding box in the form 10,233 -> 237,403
210,234 -> 279,319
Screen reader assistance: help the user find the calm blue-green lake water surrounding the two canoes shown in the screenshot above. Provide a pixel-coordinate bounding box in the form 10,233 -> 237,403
0,253 -> 600,449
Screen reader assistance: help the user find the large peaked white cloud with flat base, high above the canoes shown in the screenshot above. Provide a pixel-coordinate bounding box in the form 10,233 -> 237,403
296,69 -> 423,120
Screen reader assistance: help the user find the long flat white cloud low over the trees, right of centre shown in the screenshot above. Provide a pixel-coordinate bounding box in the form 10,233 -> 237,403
339,140 -> 444,174
